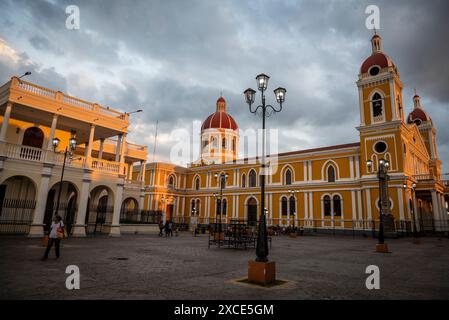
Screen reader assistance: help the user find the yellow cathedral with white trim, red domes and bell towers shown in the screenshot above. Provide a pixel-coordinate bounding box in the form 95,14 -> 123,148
136,34 -> 449,232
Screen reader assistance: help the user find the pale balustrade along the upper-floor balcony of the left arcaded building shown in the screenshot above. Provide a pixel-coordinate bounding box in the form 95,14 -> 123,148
0,142 -> 121,174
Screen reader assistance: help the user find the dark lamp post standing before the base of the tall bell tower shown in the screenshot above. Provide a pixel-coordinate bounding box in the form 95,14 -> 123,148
366,159 -> 391,253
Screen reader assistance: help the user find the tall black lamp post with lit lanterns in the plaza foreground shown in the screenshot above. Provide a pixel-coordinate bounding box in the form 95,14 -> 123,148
244,73 -> 287,284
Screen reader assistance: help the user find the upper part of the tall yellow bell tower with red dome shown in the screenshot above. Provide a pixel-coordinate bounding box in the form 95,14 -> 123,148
357,34 -> 405,174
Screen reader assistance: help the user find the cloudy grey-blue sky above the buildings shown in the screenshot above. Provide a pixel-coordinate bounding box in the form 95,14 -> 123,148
0,0 -> 449,172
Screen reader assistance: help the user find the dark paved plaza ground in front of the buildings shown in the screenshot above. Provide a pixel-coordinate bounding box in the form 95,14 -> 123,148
0,233 -> 449,299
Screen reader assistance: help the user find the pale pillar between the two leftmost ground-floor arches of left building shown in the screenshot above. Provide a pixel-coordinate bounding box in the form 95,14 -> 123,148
28,163 -> 53,238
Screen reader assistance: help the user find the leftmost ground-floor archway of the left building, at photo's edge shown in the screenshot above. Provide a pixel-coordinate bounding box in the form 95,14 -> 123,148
0,176 -> 37,234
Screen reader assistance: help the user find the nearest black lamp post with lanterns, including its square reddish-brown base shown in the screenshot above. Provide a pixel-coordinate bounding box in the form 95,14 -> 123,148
244,73 -> 287,285
